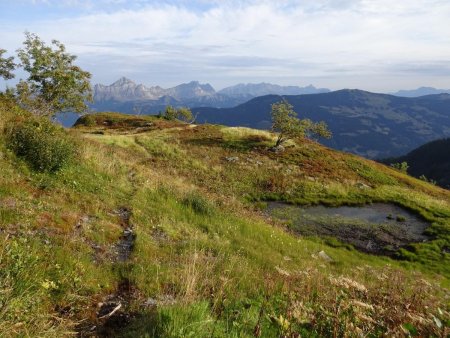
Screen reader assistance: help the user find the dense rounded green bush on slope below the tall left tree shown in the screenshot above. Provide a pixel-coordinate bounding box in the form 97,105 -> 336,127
6,117 -> 75,172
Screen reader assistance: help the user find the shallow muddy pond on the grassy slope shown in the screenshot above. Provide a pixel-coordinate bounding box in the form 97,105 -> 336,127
267,202 -> 430,256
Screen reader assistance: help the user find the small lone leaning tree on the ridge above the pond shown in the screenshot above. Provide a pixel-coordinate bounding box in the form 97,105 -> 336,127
271,100 -> 332,147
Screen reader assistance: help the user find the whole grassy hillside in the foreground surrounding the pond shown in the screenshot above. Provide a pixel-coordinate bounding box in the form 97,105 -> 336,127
0,103 -> 450,337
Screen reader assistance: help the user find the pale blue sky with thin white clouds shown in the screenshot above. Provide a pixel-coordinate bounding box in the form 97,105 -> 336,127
0,0 -> 450,92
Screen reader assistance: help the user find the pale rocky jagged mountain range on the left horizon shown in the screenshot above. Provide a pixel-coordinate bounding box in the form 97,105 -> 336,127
91,77 -> 330,114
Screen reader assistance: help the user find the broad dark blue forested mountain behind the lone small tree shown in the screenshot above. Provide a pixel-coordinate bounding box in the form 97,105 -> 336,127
193,90 -> 450,158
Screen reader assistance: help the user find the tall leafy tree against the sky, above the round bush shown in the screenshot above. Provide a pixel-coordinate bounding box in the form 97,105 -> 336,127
17,32 -> 92,116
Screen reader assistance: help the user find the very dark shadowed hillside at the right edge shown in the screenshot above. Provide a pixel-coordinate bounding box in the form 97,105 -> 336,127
382,138 -> 450,189
